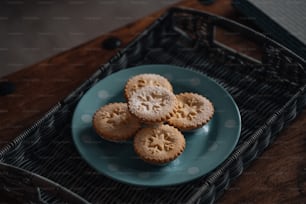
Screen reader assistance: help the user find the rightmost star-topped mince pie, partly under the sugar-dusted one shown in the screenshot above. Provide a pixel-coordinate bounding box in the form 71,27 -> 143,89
168,93 -> 214,131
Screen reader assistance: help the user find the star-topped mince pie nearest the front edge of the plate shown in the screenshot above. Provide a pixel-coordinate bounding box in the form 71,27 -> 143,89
134,125 -> 186,164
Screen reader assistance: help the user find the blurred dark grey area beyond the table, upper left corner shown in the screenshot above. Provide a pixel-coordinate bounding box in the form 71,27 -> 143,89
0,0 -> 179,77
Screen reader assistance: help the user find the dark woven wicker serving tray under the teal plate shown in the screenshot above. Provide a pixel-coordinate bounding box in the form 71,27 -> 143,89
0,8 -> 306,203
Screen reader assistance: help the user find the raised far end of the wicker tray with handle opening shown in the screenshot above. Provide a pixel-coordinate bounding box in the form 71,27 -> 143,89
170,7 -> 306,84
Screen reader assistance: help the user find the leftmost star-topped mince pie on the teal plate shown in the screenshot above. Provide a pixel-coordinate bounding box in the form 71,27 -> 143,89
93,103 -> 141,142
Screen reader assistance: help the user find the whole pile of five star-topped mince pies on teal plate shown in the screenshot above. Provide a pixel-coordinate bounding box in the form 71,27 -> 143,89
93,74 -> 214,164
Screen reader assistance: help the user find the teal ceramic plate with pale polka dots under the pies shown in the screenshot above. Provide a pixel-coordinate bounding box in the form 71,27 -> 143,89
72,65 -> 241,186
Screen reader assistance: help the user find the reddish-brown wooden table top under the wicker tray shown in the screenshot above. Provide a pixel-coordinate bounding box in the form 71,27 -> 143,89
0,0 -> 306,204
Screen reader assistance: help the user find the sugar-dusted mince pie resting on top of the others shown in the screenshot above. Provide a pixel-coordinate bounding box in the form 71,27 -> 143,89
128,86 -> 176,123
